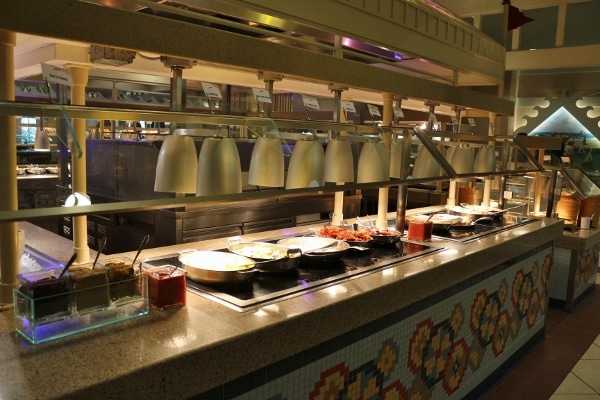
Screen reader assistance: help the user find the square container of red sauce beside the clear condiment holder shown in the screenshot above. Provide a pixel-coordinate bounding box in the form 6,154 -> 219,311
144,265 -> 186,310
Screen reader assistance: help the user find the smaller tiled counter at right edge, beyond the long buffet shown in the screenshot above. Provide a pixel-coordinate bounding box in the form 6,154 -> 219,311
550,227 -> 600,311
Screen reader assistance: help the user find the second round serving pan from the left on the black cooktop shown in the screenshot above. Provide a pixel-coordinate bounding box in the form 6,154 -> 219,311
228,242 -> 302,272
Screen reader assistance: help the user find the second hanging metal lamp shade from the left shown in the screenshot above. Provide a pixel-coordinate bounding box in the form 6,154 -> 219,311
196,138 -> 242,196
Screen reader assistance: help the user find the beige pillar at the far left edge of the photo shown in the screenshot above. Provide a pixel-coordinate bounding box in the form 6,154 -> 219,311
0,30 -> 20,309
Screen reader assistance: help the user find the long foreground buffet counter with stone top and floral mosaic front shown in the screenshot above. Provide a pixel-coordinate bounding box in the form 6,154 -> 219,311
0,207 -> 563,399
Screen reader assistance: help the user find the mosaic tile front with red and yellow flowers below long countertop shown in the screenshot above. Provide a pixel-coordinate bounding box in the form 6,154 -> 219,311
197,246 -> 552,400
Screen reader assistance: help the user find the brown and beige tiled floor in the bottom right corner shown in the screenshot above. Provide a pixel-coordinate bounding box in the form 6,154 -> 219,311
483,284 -> 600,400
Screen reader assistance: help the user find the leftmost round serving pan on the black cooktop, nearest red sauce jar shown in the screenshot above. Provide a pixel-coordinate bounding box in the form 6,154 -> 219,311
179,250 -> 256,284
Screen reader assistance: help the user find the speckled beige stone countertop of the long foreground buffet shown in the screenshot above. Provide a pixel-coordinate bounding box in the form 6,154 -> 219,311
0,211 -> 563,399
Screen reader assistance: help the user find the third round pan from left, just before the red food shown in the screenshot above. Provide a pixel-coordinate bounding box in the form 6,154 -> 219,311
277,236 -> 350,267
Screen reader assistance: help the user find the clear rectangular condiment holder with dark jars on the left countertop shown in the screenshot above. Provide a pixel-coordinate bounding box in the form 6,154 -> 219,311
13,271 -> 149,344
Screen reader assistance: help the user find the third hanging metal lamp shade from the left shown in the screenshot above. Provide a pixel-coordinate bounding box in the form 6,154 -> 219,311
248,137 -> 284,187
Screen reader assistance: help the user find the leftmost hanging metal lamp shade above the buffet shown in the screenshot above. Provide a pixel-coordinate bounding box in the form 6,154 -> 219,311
154,135 -> 198,193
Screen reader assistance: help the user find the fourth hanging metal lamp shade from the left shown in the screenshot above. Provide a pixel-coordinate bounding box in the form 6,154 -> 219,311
285,140 -> 325,189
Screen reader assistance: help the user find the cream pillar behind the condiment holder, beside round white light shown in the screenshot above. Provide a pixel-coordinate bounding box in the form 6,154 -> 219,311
68,65 -> 90,264
